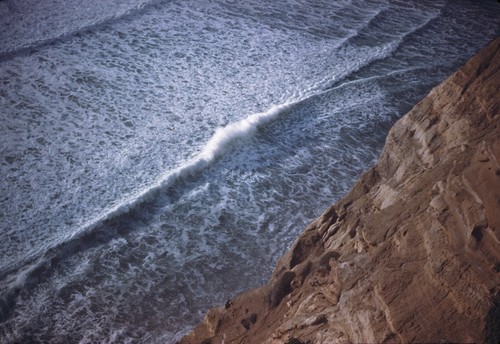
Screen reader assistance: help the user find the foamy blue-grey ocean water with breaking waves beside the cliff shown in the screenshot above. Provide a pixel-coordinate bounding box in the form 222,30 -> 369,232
0,0 -> 500,343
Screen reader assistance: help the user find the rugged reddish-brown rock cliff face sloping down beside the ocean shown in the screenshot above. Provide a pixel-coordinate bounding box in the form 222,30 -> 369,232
181,38 -> 500,344
